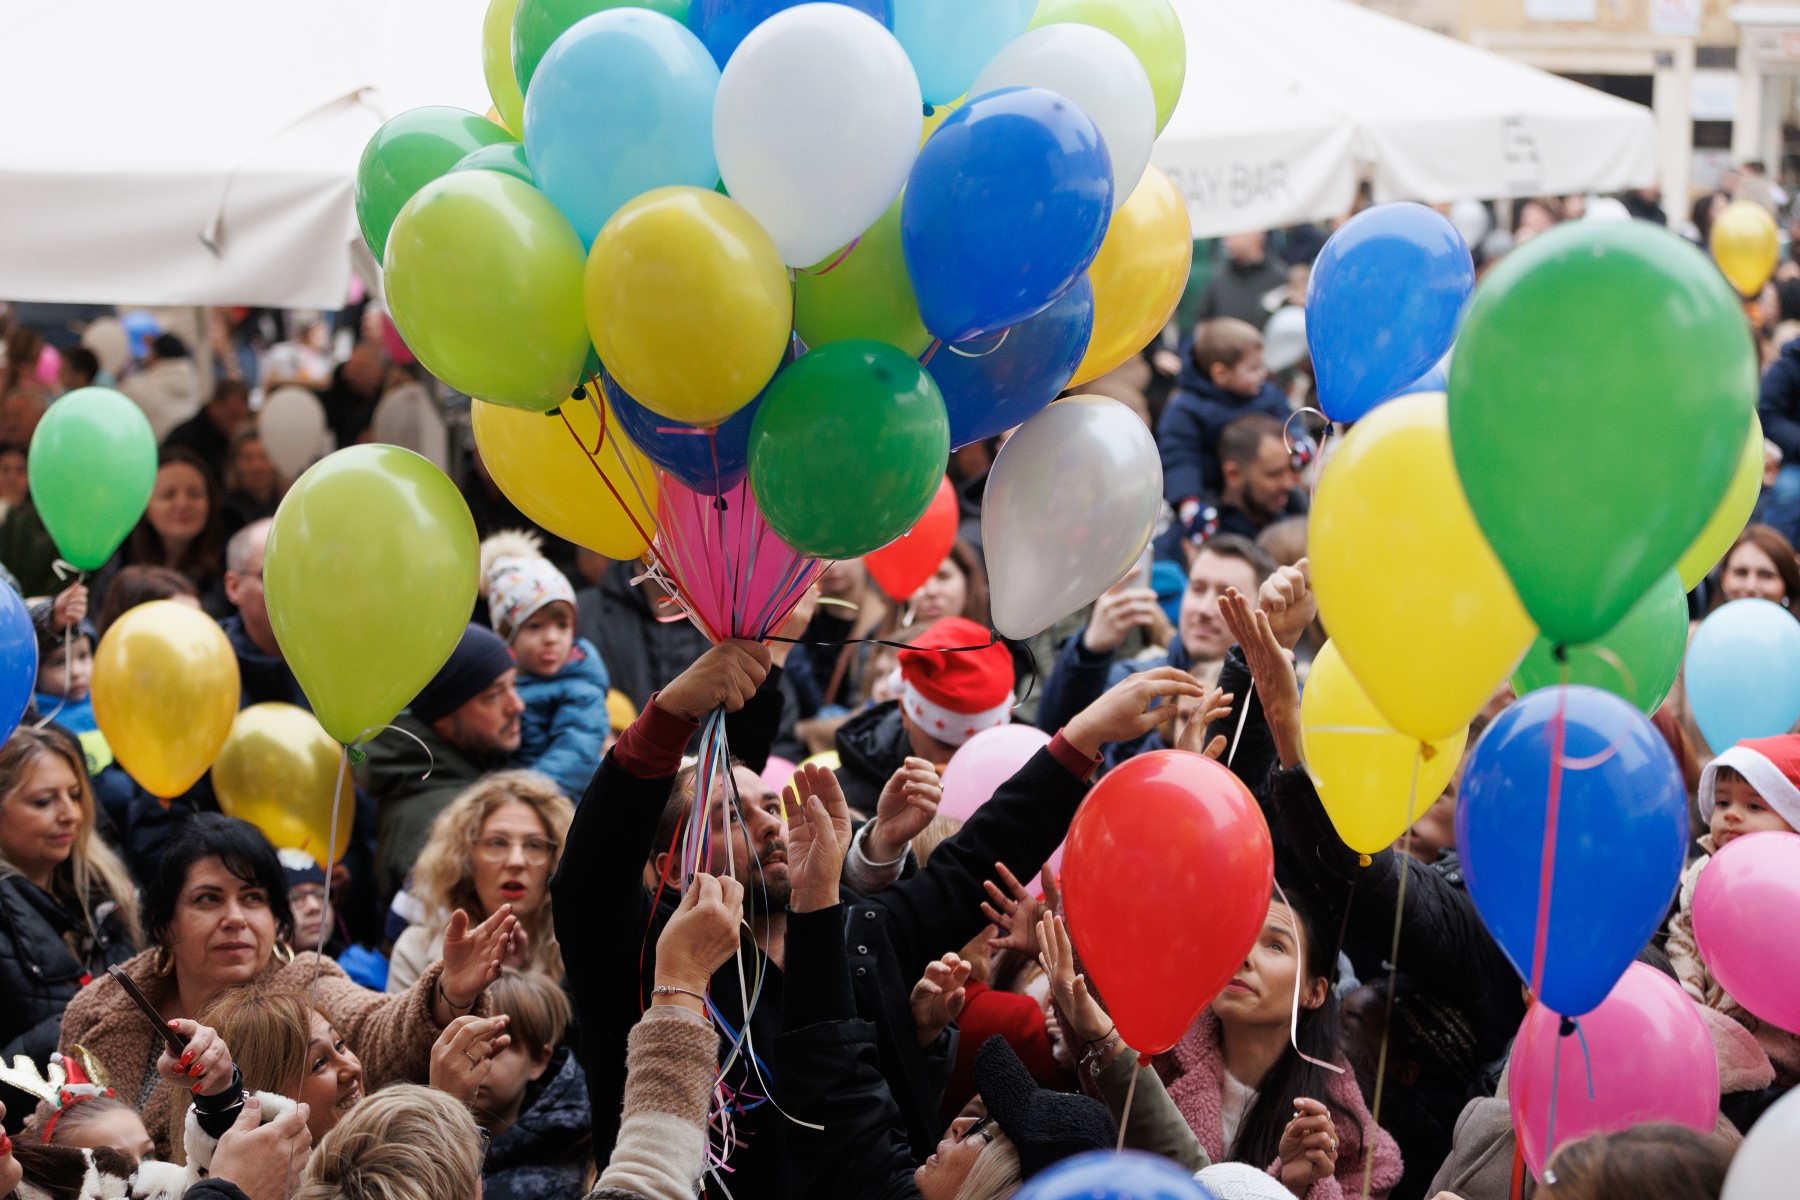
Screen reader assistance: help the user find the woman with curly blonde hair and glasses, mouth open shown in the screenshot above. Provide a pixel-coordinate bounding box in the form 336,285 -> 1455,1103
387,770 -> 574,991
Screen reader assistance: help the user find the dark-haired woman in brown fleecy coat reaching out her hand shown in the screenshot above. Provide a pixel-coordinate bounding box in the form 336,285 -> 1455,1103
40,813 -> 518,1153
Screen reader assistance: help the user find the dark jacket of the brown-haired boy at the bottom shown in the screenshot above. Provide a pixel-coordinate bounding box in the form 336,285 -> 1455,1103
481,1047 -> 594,1200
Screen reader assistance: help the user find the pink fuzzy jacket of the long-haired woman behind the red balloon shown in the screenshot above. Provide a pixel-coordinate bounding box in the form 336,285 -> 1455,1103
1163,1009 -> 1400,1200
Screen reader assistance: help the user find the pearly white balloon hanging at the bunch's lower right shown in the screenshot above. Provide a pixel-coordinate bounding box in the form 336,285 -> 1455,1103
981,396 -> 1163,639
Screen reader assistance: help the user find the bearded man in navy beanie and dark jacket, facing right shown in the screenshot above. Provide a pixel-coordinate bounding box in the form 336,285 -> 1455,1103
358,624 -> 526,903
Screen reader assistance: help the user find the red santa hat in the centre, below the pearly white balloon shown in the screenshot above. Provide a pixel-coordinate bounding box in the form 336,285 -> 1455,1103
900,617 -> 1013,747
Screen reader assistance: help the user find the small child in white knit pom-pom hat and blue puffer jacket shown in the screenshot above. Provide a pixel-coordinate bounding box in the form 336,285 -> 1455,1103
481,531 -> 612,801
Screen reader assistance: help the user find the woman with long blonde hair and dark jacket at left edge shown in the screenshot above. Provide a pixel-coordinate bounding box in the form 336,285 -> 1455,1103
0,725 -> 142,1128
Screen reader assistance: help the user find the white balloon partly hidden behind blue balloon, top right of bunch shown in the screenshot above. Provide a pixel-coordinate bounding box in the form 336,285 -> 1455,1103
968,23 -> 1156,210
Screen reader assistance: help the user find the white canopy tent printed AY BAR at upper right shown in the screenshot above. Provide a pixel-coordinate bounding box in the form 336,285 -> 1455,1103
1152,0 -> 1656,237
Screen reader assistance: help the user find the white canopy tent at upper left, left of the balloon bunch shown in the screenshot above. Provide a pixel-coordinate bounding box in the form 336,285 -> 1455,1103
0,0 -> 488,308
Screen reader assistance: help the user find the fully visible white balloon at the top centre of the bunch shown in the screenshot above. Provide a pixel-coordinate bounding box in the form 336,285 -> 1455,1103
713,4 -> 925,266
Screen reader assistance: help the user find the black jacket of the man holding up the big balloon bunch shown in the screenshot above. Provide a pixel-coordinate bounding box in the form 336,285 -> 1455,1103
551,684 -> 1087,1196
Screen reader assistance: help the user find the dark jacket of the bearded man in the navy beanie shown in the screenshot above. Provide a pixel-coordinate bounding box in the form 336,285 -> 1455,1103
356,712 -> 506,907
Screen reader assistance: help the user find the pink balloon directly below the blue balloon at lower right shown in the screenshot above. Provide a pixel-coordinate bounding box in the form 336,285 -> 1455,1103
1507,963 -> 1719,1178
